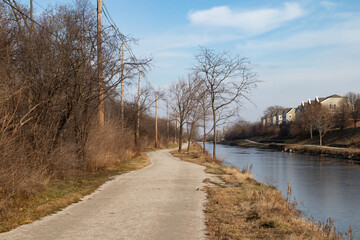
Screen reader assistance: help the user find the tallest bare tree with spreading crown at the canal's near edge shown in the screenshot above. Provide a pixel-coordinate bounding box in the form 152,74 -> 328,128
193,48 -> 259,158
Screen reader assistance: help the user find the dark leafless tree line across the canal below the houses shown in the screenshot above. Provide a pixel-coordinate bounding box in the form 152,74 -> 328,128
225,92 -> 360,146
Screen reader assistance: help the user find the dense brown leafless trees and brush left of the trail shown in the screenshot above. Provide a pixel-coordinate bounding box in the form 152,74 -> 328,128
0,0 -> 175,216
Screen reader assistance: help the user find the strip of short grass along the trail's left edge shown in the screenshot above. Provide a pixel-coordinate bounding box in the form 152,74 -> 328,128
0,154 -> 150,232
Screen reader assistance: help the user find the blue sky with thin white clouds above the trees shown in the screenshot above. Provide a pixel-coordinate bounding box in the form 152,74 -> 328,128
26,0 -> 360,122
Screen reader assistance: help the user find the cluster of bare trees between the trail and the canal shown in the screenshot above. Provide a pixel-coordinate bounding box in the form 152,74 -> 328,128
169,47 -> 260,158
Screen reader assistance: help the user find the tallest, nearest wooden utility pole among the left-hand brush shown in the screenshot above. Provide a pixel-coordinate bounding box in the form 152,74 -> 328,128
97,0 -> 104,128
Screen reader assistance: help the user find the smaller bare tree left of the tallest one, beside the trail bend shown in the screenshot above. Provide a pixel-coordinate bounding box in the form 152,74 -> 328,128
170,74 -> 201,152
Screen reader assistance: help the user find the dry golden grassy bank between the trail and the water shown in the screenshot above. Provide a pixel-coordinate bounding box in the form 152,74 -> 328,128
173,145 -> 347,240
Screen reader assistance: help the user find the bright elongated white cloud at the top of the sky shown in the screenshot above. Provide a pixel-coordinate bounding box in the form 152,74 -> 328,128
188,2 -> 305,34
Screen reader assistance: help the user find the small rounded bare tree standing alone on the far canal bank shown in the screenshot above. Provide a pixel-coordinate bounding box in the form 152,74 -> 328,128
315,106 -> 334,147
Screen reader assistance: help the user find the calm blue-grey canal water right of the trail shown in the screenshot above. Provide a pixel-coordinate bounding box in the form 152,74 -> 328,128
206,143 -> 360,236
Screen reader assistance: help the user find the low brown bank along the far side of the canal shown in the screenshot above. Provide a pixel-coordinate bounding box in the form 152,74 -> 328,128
226,140 -> 360,164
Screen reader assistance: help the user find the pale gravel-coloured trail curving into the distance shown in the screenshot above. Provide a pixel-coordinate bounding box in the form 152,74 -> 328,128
0,150 -> 207,240
